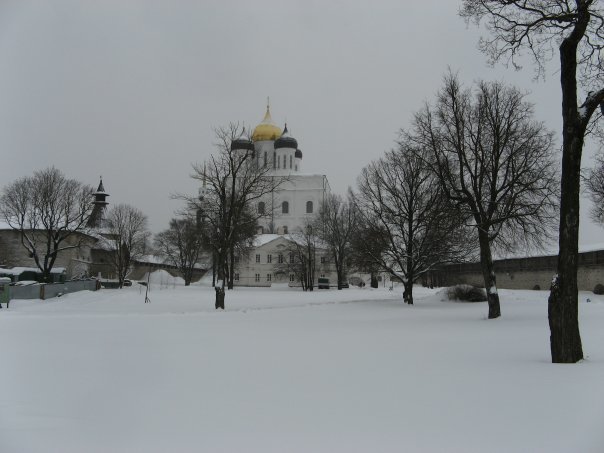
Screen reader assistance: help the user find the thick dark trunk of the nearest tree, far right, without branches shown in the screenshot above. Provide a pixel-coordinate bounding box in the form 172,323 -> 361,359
548,40 -> 585,363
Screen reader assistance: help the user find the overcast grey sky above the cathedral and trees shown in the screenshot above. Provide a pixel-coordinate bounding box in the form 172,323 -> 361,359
0,0 -> 602,245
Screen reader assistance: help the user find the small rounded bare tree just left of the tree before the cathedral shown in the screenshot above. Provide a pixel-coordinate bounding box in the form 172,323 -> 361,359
154,215 -> 203,286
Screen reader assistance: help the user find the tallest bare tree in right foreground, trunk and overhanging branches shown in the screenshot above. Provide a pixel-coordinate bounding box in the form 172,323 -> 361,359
461,0 -> 604,363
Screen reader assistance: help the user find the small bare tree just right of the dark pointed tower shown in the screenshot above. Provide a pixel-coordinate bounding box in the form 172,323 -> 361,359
104,204 -> 150,288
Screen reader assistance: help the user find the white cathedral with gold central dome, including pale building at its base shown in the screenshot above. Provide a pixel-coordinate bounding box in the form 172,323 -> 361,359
214,105 -> 336,286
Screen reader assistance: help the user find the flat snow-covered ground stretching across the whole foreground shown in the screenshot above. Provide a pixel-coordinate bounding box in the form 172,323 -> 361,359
0,283 -> 604,453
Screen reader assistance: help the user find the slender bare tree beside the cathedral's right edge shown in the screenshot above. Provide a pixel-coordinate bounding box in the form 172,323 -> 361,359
316,194 -> 357,289
